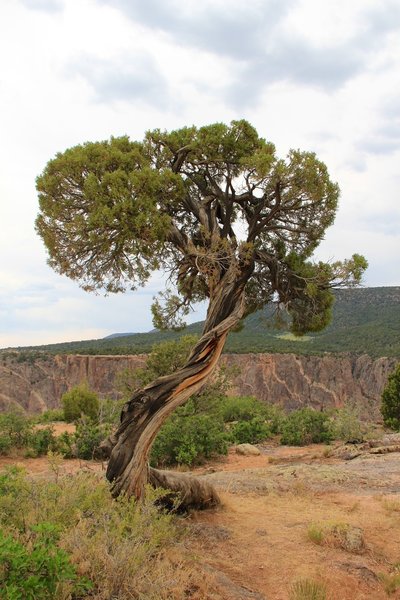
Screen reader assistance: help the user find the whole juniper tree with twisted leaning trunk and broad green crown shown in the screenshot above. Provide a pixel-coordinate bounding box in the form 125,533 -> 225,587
36,120 -> 366,504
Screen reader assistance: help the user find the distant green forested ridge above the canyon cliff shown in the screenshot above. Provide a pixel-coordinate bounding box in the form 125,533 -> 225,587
3,287 -> 400,358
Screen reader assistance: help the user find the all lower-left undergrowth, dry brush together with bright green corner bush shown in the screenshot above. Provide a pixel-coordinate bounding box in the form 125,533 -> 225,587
0,467 -> 216,600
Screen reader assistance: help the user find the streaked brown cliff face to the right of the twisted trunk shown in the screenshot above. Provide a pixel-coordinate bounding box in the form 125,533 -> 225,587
223,354 -> 398,420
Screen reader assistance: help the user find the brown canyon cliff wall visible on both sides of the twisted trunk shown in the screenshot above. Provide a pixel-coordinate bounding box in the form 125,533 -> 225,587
0,354 -> 397,419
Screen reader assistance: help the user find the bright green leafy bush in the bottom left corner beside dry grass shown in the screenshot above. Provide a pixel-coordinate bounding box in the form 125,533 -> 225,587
0,523 -> 92,600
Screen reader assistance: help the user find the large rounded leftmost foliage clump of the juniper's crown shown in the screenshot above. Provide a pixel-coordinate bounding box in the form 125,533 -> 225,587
36,137 -> 182,292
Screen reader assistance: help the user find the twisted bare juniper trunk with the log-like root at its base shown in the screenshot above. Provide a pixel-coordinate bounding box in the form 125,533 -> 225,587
101,269 -> 244,506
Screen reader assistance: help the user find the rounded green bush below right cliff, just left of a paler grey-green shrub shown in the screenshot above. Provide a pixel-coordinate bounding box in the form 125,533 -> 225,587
281,408 -> 332,446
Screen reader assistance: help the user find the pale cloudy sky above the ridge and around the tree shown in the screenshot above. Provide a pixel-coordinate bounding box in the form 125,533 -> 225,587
0,0 -> 400,348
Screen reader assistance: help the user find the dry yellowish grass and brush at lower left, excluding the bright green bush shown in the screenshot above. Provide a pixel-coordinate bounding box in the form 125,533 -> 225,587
0,461 -> 217,600
